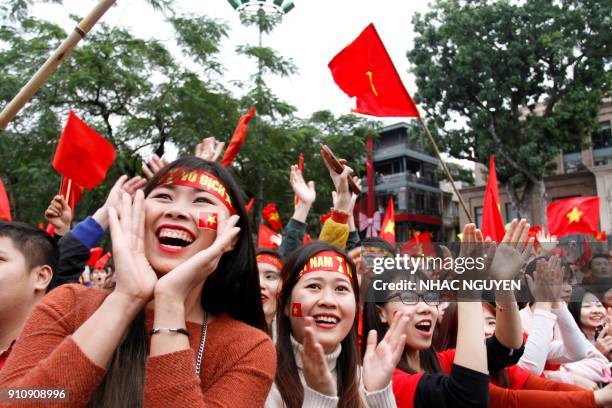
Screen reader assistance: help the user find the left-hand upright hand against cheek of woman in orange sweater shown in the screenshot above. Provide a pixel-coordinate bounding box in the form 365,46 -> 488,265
108,190 -> 157,306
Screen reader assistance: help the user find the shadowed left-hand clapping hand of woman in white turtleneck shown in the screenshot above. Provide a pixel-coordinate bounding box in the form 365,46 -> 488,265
300,317 -> 338,397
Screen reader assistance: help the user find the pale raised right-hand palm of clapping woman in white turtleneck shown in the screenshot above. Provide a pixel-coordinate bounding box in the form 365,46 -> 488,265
363,312 -> 410,392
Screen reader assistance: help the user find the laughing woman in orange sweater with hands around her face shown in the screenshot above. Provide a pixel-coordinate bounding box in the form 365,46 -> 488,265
0,157 -> 276,407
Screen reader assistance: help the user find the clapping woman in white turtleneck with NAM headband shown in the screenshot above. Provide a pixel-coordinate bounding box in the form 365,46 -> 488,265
265,242 -> 407,408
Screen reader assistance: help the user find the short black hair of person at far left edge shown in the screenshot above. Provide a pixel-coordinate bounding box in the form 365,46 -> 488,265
0,221 -> 59,284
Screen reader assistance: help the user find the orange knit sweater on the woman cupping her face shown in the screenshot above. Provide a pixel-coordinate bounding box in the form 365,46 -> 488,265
0,285 -> 276,408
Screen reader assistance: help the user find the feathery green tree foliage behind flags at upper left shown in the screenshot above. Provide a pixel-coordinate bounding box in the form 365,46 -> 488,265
0,0 -> 377,235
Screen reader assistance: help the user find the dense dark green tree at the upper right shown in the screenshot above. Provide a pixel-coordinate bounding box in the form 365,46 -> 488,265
408,0 -> 612,222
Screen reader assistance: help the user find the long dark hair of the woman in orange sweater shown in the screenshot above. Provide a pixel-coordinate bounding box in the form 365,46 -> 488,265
89,156 -> 266,408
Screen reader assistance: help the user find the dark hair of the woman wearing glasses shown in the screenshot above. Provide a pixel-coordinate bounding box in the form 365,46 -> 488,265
361,269 -> 442,374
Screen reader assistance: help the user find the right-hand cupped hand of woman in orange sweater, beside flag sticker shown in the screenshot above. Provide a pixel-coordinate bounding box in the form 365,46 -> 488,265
155,215 -> 240,302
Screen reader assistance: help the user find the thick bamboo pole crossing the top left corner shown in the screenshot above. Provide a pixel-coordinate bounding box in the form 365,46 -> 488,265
0,0 -> 117,133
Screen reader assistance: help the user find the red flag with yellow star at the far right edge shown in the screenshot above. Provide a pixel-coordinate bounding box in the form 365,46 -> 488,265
546,196 -> 599,238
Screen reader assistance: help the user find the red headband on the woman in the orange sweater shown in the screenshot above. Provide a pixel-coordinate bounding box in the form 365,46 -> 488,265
155,167 -> 236,215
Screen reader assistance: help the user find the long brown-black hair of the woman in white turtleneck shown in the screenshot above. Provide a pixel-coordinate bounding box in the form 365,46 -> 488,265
274,241 -> 363,408
